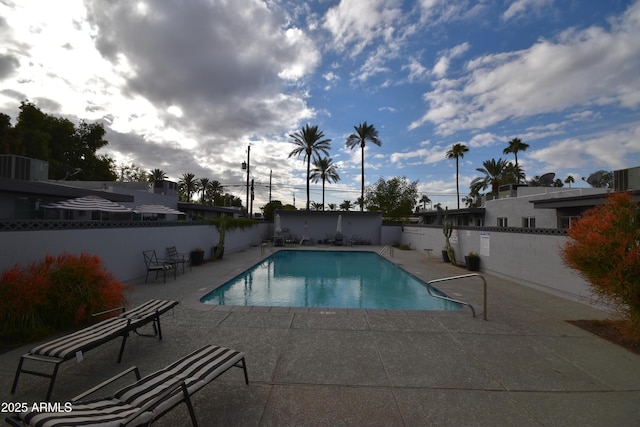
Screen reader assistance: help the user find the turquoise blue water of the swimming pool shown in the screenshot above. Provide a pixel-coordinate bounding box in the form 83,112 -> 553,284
201,250 -> 461,310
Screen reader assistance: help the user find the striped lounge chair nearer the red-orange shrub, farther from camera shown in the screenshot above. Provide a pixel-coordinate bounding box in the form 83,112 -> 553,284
11,300 -> 178,400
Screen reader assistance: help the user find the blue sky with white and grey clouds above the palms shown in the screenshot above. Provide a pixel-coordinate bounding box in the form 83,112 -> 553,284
0,0 -> 640,212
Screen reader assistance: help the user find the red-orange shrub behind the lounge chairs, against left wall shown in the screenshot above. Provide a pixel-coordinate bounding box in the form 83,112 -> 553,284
0,253 -> 126,340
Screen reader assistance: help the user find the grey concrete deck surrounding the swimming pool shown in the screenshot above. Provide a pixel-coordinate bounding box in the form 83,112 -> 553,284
0,246 -> 640,426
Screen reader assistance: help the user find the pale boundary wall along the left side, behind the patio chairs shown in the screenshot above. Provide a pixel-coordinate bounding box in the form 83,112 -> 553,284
0,224 -> 268,282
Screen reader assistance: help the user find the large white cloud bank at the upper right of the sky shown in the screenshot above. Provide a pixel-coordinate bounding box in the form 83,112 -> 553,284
410,2 -> 640,135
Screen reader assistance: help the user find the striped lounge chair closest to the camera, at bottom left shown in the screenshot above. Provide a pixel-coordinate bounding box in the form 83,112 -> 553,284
7,345 -> 249,427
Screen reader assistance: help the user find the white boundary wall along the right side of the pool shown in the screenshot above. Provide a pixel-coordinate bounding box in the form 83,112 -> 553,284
401,226 -> 591,303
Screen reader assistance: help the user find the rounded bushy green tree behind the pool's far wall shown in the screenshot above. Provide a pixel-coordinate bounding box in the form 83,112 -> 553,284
365,177 -> 418,217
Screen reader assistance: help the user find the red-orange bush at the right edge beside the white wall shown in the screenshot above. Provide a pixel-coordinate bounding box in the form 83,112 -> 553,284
561,193 -> 640,336
